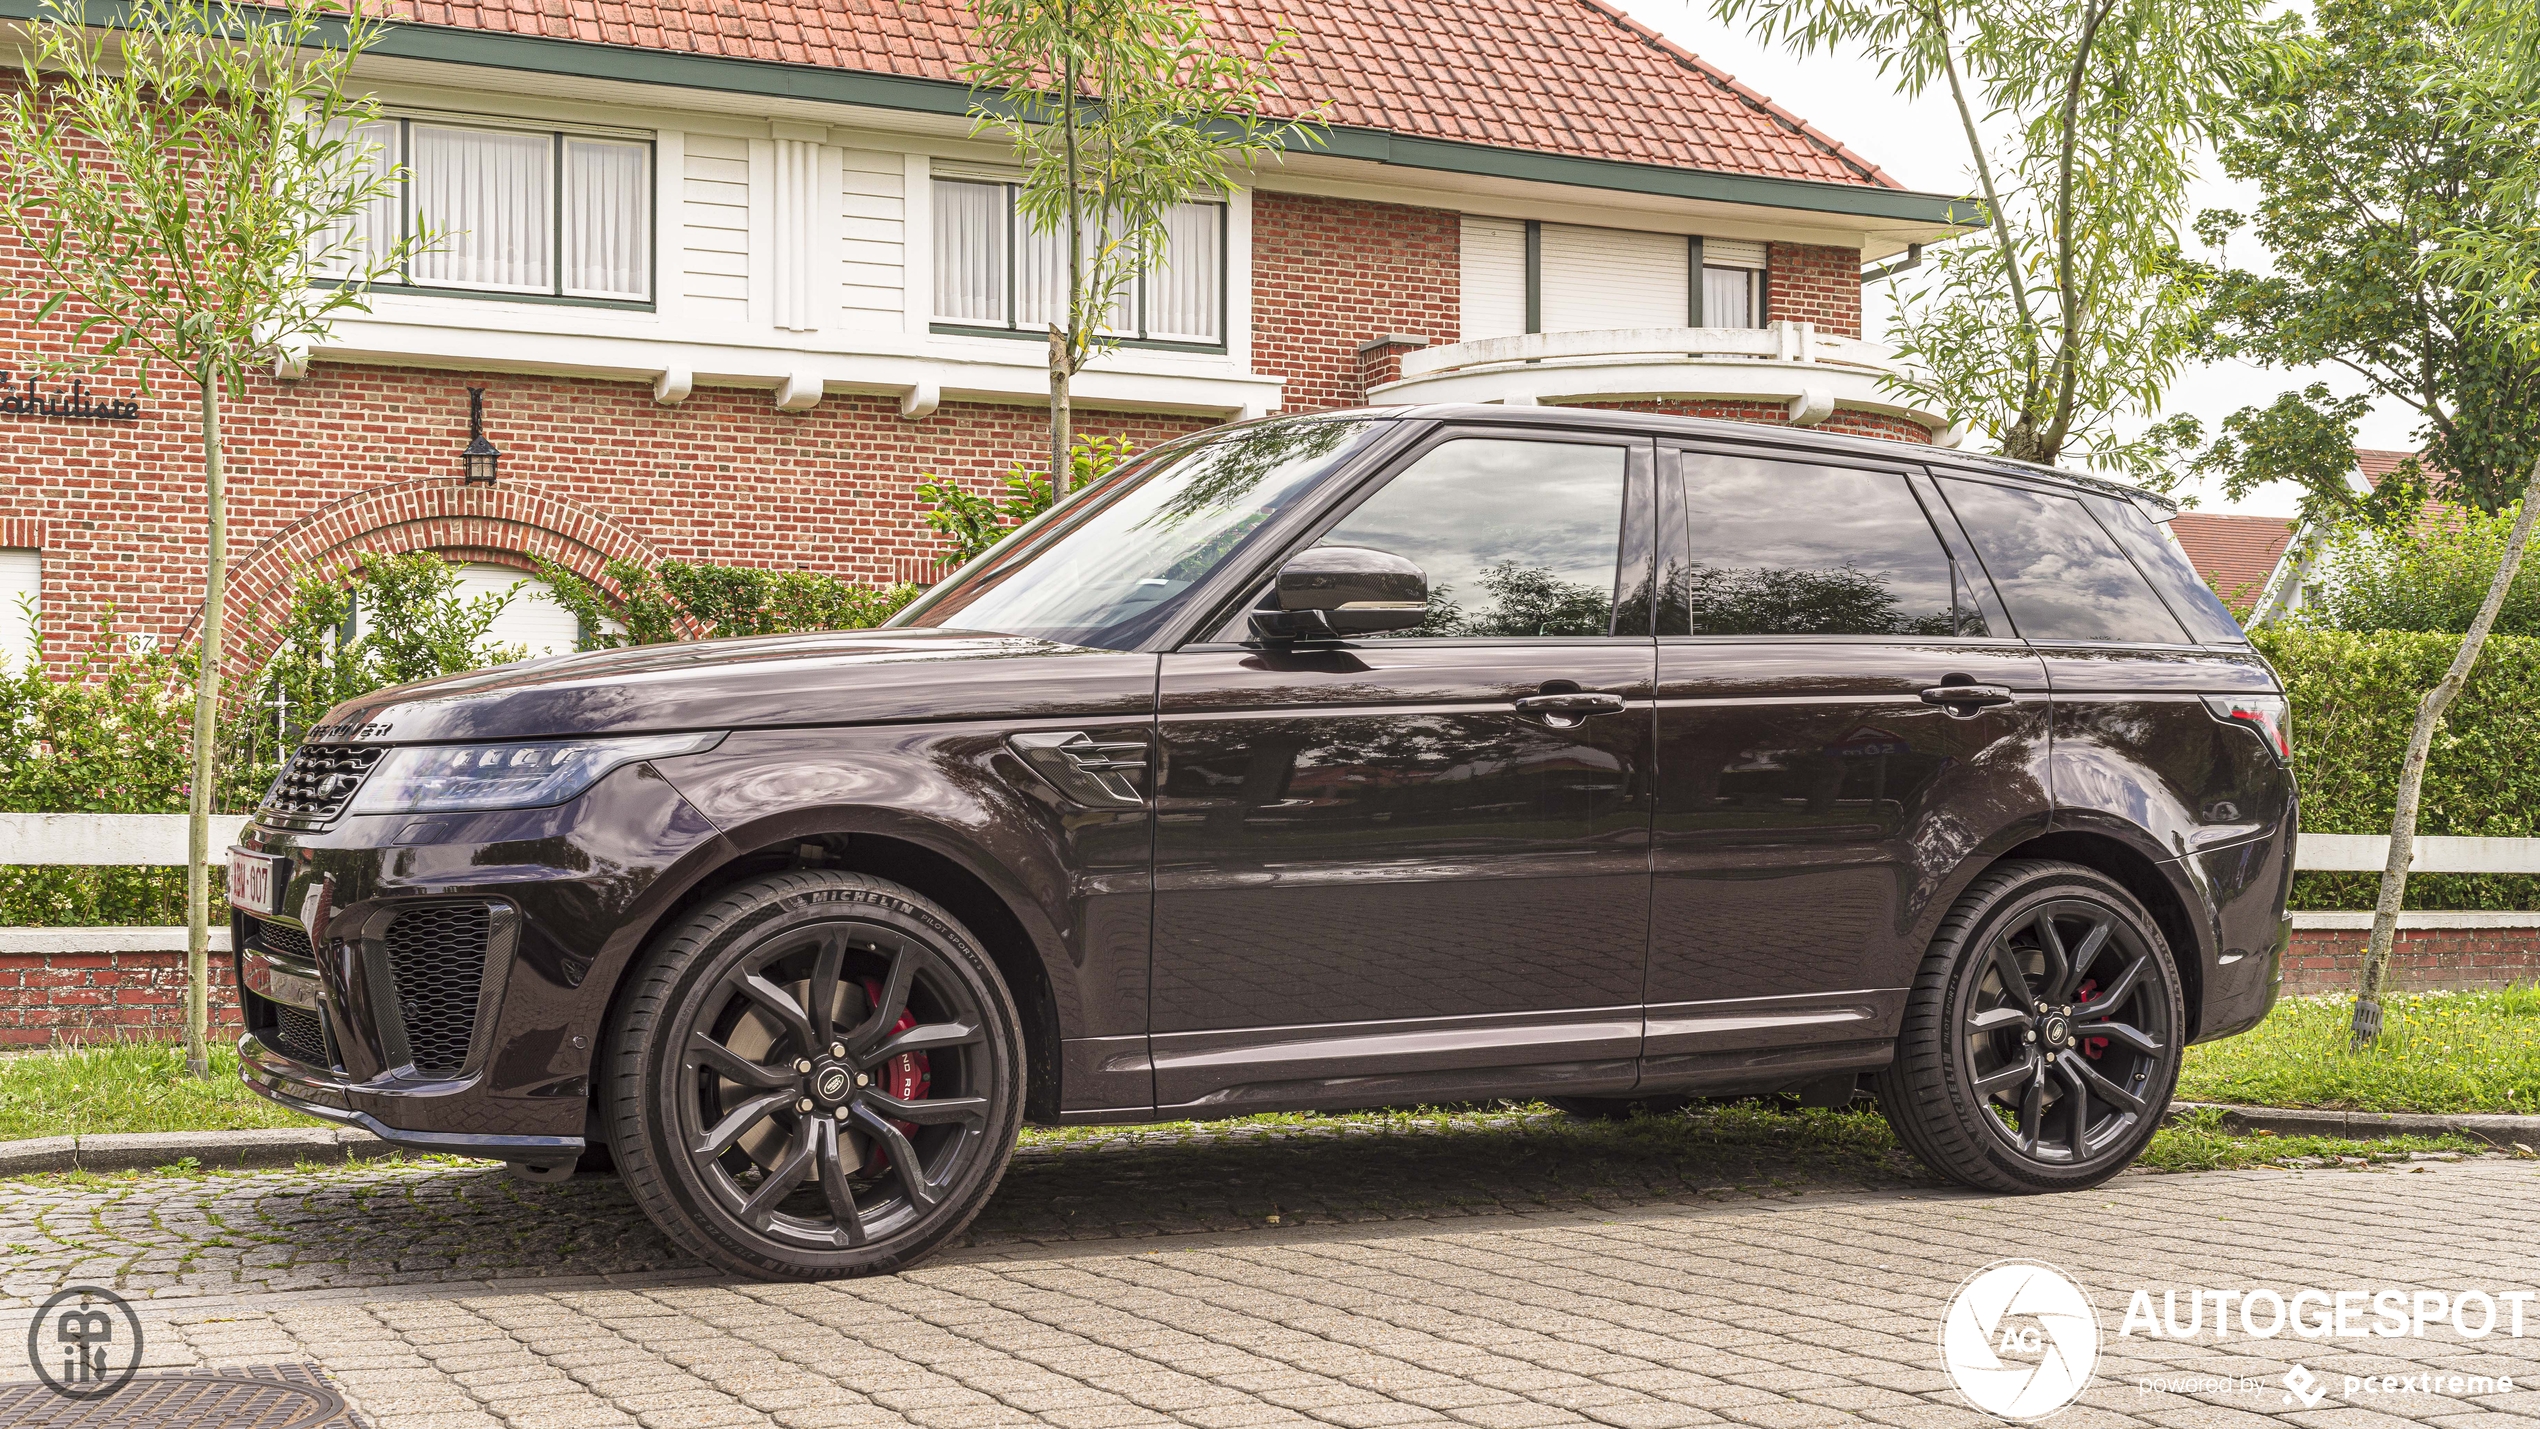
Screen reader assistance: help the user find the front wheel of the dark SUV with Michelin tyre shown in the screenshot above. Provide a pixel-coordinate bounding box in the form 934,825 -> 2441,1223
602,871 -> 1024,1279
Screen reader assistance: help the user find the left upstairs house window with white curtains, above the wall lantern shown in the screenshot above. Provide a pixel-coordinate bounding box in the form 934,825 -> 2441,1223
322,117 -> 653,302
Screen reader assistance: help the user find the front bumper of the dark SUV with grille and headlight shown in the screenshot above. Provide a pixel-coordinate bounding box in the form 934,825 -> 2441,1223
231,764 -> 721,1162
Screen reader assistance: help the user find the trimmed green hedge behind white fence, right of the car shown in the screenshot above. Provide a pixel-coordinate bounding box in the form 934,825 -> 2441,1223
2253,624 -> 2540,909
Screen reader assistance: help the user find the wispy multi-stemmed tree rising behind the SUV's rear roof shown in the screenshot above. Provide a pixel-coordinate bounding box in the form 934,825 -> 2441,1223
1712,0 -> 2266,477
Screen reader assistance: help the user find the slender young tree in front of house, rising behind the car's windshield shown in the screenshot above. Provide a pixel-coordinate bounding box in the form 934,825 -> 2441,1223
963,0 -> 1321,495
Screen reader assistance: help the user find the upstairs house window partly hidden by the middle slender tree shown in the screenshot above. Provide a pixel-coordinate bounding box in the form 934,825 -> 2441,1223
935,178 -> 1227,348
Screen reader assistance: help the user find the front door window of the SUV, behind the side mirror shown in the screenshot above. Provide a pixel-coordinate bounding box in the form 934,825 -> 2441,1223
1318,439 -> 1628,637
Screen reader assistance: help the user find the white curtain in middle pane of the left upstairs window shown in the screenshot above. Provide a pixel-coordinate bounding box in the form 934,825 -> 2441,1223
411,124 -> 556,292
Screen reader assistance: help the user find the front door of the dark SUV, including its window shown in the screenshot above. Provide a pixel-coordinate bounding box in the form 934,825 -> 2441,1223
1151,429 -> 1656,1107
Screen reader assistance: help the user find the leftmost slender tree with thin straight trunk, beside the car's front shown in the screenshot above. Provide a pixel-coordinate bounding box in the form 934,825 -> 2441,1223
0,0 -> 417,1076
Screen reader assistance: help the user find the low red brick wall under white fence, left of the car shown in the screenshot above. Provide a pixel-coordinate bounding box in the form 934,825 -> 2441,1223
0,952 -> 241,1046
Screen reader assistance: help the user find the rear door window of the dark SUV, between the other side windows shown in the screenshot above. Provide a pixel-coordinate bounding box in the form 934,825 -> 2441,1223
1659,452 -> 1984,637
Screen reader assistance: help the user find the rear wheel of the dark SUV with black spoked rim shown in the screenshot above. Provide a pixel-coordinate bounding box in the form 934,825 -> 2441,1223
1875,860 -> 2187,1190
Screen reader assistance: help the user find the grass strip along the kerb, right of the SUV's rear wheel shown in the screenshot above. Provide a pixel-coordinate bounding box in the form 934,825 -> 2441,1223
2179,987 -> 2540,1114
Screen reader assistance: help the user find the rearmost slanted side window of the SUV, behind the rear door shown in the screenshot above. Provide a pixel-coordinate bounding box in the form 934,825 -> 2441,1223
1941,480 -> 2187,645
